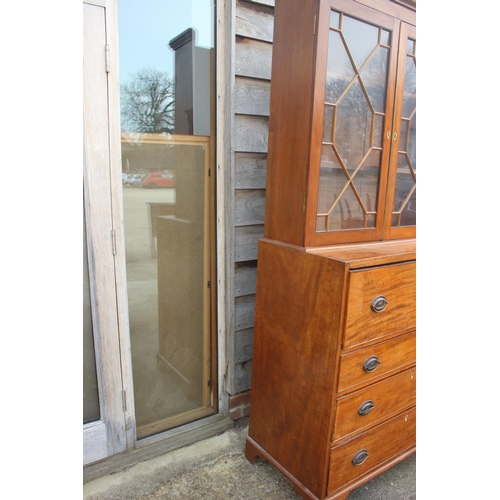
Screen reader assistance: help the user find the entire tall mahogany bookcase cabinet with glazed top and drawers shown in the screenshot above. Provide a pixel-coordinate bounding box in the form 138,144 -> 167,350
246,0 -> 416,500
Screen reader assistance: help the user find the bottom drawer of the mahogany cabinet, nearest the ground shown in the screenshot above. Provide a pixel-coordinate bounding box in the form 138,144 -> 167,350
328,408 -> 416,495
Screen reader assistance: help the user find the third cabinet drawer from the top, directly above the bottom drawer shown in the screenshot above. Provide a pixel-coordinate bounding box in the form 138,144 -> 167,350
334,368 -> 417,441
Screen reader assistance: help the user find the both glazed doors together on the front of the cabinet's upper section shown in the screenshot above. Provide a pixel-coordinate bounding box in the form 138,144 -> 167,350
306,0 -> 415,245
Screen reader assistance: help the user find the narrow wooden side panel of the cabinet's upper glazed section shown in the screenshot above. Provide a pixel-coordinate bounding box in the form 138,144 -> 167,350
264,0 -> 316,245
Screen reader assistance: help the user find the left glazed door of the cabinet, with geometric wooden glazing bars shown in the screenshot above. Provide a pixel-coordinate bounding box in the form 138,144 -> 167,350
312,0 -> 399,243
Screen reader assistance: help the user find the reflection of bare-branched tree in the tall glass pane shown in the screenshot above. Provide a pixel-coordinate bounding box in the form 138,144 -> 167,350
121,68 -> 175,133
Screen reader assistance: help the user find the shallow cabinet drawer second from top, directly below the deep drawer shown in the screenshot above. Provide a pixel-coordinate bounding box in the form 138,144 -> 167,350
338,332 -> 417,392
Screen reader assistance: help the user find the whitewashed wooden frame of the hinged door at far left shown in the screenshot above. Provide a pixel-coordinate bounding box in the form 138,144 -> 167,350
83,1 -> 133,465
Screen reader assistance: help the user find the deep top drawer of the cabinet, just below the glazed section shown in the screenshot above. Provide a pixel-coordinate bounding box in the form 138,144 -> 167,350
343,262 -> 416,348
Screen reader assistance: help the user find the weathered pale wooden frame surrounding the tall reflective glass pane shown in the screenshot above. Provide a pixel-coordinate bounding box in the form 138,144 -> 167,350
83,0 -> 231,470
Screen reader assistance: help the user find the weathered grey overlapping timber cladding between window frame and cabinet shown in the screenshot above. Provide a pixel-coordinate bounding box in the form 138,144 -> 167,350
228,0 -> 274,394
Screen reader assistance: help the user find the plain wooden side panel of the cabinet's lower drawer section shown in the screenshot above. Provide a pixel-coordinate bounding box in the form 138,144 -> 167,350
249,240 -> 344,498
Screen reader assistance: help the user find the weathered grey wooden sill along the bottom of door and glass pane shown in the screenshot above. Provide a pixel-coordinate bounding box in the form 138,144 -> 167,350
83,414 -> 234,483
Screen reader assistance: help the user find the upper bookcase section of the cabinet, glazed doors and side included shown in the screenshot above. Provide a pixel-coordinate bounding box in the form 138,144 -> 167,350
264,0 -> 416,246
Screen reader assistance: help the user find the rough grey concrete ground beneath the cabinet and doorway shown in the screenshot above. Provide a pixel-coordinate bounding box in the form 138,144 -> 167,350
83,418 -> 416,500
